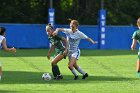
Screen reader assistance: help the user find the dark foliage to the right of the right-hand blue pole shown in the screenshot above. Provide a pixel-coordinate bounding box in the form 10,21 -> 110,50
105,0 -> 140,25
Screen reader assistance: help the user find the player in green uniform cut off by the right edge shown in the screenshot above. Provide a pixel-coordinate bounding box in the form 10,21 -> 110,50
131,18 -> 140,76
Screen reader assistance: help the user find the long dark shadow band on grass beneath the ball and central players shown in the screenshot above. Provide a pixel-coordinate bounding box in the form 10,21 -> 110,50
0,71 -> 137,84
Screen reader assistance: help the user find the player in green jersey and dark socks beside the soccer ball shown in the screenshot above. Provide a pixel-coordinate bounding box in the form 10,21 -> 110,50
46,24 -> 68,80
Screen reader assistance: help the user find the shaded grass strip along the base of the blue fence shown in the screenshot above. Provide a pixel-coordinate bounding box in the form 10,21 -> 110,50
0,49 -> 137,57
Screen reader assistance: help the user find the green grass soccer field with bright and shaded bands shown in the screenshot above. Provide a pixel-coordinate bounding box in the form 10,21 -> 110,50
0,49 -> 140,93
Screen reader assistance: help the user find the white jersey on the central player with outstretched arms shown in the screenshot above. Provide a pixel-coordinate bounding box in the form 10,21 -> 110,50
64,29 -> 88,52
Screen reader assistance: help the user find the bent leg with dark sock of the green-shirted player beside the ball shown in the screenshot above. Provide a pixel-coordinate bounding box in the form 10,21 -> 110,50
51,54 -> 64,79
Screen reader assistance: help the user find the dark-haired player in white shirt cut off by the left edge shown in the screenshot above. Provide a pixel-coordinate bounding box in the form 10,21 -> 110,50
0,27 -> 16,80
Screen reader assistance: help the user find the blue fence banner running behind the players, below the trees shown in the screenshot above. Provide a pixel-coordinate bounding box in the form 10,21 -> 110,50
0,24 -> 137,49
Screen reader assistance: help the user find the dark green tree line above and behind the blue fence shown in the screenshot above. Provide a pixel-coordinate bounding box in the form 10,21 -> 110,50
0,0 -> 140,25
